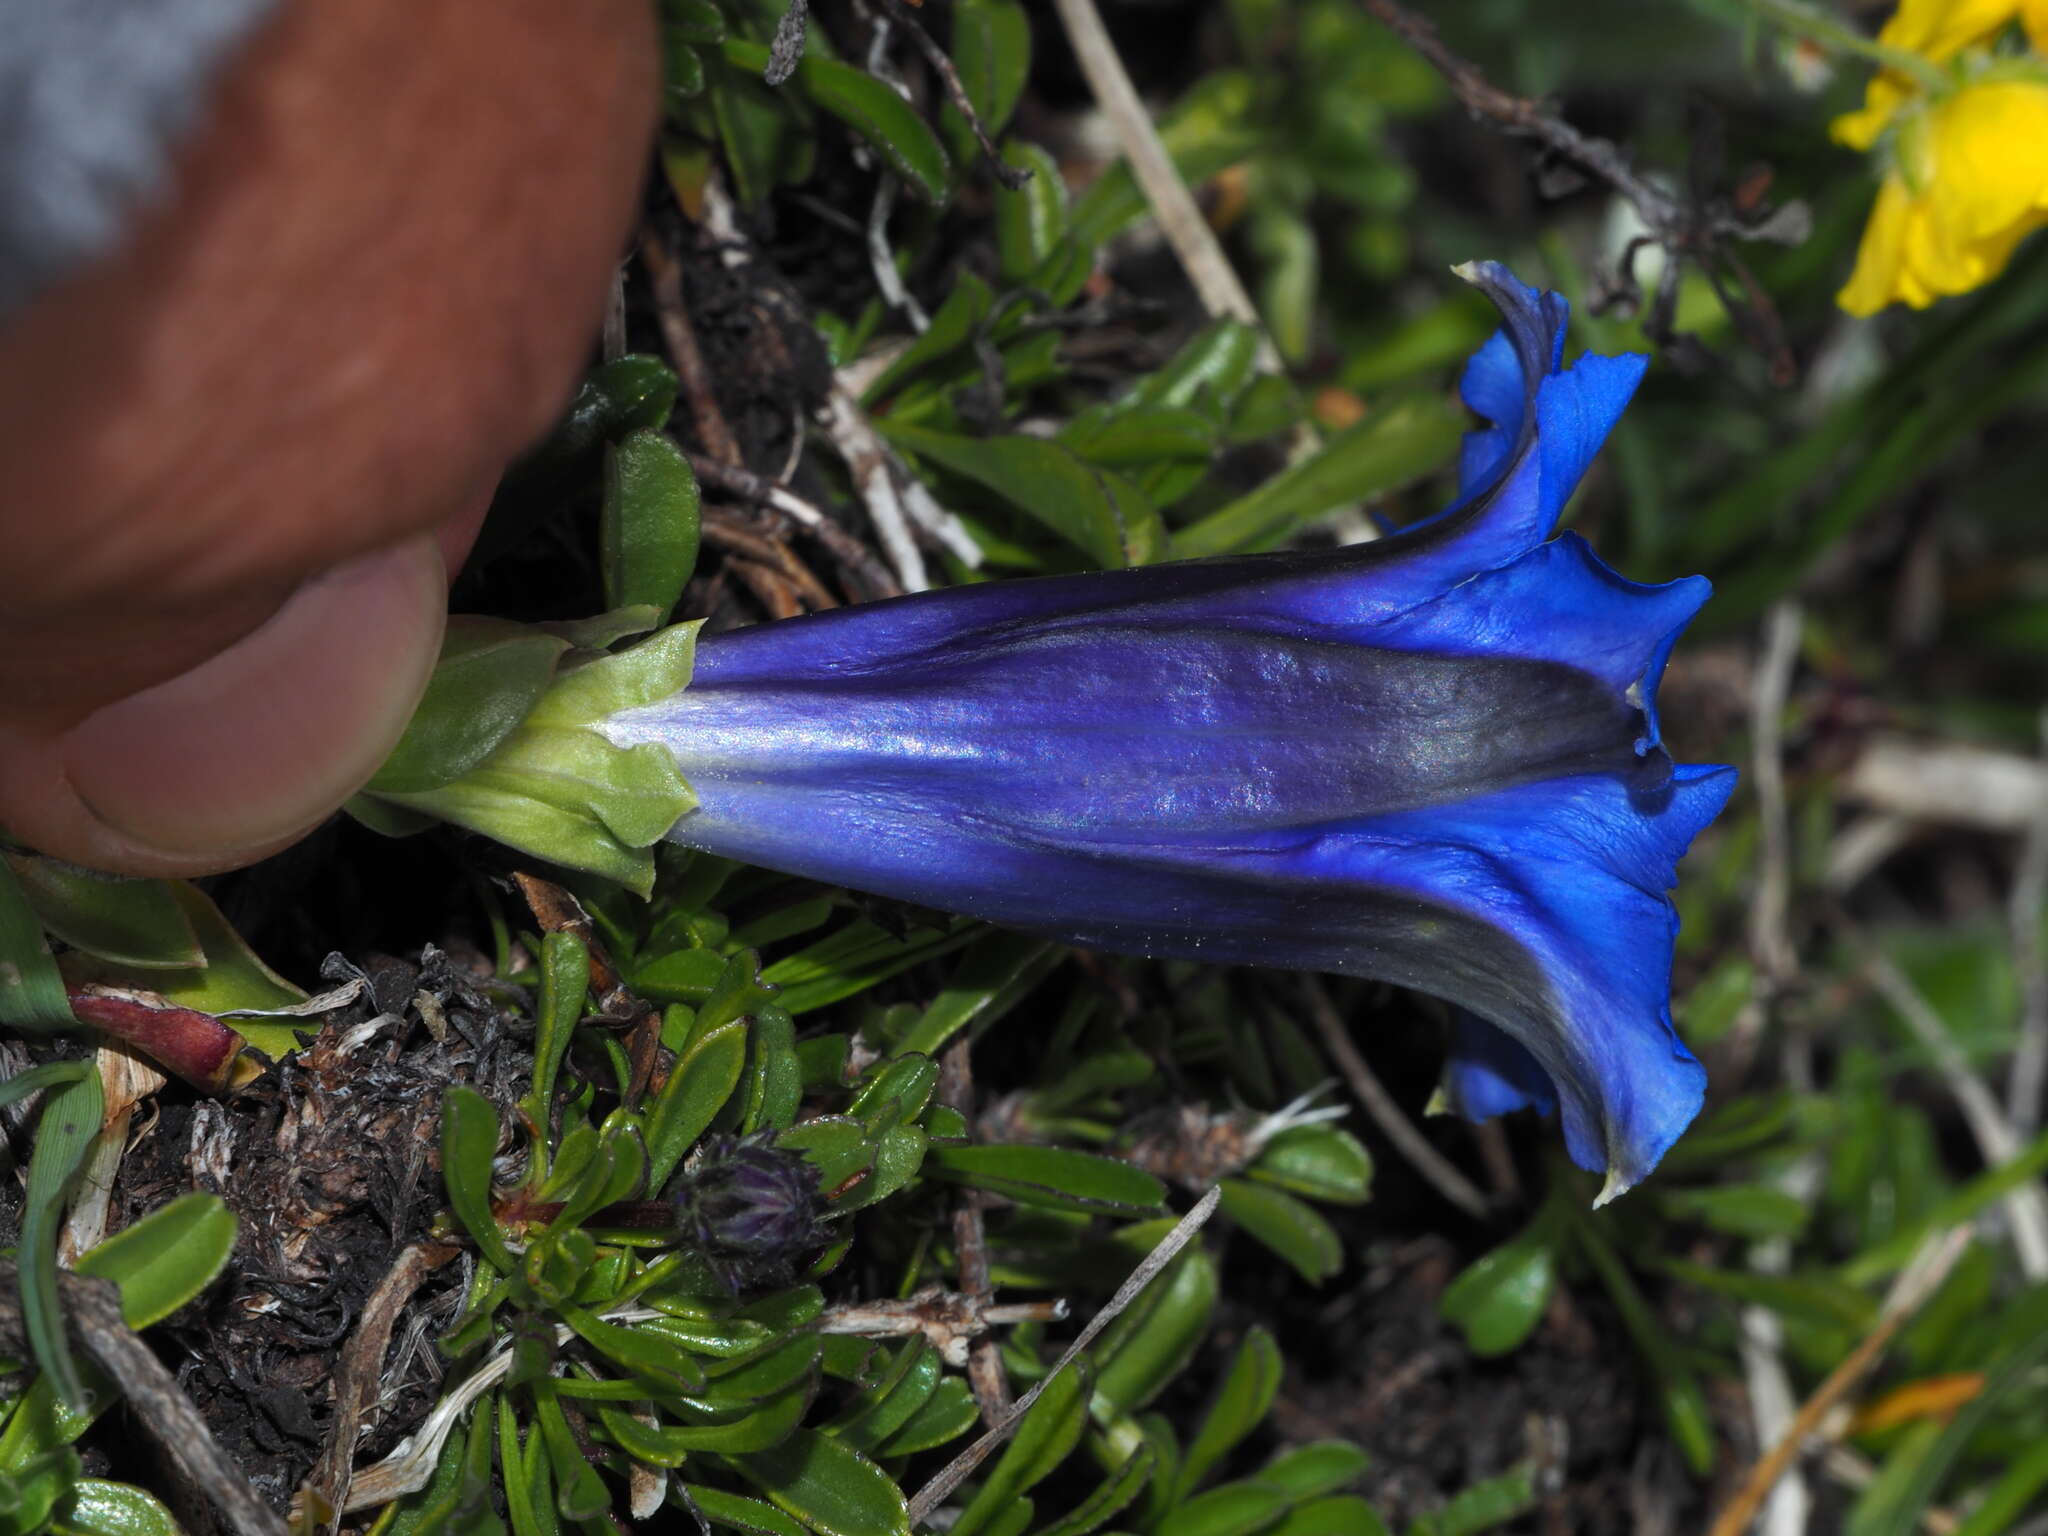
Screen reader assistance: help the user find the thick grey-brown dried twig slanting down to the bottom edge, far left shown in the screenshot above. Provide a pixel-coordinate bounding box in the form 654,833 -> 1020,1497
0,1264 -> 287,1536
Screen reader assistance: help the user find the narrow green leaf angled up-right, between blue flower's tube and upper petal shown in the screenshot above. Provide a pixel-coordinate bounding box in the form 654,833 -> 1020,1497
1174,395 -> 1464,559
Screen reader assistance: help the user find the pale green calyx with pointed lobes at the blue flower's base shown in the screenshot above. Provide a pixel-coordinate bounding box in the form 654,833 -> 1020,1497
348,618 -> 698,895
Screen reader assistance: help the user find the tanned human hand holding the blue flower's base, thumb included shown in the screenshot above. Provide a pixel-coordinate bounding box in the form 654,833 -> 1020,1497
0,0 -> 657,874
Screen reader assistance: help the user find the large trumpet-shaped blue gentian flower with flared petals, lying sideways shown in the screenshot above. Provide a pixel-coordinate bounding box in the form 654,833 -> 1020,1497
604,264 -> 1735,1198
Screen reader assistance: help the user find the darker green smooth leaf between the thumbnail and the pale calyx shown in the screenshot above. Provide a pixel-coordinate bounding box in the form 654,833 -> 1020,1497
365,618 -> 569,795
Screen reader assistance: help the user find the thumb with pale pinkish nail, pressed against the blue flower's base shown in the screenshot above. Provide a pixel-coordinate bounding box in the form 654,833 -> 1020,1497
0,537 -> 446,874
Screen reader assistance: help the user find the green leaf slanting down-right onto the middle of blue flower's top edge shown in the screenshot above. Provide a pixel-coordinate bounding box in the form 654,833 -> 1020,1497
877,420 -> 1165,569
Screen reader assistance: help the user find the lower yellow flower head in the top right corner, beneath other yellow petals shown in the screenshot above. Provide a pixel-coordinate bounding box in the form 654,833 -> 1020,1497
1835,80 -> 2048,315
